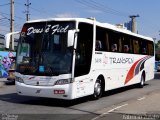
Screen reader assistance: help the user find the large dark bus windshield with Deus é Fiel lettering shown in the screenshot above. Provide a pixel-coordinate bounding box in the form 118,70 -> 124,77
16,21 -> 75,76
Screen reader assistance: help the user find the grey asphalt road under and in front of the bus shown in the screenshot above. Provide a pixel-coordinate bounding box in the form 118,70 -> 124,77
0,73 -> 160,120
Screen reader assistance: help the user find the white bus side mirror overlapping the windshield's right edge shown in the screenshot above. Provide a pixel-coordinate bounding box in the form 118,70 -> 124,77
67,30 -> 79,47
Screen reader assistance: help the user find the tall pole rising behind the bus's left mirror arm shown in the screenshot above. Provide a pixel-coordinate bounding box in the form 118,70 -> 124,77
10,0 -> 14,50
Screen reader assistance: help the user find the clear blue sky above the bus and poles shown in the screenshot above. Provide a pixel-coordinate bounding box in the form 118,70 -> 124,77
0,0 -> 160,40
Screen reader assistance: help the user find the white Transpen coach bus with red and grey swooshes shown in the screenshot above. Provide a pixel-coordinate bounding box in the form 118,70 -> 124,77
15,18 -> 155,99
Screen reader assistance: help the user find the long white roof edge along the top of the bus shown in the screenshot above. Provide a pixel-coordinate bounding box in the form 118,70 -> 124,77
26,18 -> 153,41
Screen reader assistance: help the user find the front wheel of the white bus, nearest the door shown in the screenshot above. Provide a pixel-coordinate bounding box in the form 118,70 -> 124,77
93,79 -> 102,99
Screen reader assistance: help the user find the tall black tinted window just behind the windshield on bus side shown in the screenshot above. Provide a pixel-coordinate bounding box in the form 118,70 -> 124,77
75,23 -> 93,76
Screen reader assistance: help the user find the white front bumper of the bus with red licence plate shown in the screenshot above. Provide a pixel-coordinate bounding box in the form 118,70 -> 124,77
16,81 -> 74,99
